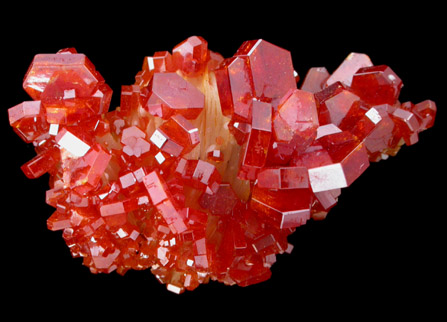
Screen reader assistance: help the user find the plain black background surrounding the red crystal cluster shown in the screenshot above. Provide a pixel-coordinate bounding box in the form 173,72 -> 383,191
0,2 -> 446,319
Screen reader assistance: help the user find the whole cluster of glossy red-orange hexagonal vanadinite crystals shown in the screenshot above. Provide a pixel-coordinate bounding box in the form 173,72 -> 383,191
8,36 -> 436,293
